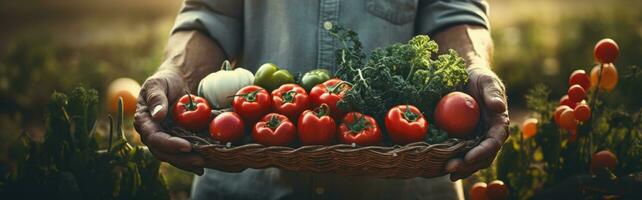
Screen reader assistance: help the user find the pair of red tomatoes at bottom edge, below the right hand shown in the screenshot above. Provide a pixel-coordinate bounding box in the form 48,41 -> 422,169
469,180 -> 508,200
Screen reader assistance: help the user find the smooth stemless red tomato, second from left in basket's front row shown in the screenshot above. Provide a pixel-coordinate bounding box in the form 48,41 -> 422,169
210,112 -> 245,143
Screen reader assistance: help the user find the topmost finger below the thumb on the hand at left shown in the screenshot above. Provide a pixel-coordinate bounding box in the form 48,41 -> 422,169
134,108 -> 192,153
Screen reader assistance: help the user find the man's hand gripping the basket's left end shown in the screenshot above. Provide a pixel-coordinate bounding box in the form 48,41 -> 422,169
134,69 -> 204,175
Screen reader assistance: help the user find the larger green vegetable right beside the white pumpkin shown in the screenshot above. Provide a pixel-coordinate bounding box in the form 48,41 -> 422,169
254,63 -> 294,91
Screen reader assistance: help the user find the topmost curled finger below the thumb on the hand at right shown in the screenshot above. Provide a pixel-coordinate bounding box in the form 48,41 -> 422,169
464,124 -> 508,163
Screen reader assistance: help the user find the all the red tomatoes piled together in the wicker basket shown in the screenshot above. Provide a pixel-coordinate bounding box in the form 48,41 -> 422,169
173,78 -> 479,146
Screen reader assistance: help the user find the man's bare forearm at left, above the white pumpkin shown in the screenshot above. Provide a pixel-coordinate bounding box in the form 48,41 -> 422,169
159,31 -> 225,92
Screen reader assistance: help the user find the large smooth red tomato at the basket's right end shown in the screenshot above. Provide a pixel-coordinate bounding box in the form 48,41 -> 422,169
434,92 -> 479,138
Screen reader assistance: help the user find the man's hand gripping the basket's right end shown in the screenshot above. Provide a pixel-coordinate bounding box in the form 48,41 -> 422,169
446,67 -> 509,181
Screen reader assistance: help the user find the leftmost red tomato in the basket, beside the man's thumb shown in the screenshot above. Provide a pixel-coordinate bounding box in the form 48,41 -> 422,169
173,93 -> 212,131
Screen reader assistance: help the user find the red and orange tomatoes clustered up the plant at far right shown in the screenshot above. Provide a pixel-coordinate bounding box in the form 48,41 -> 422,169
554,38 -> 620,142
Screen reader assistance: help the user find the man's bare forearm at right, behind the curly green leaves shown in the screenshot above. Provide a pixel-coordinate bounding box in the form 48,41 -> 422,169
434,25 -> 493,67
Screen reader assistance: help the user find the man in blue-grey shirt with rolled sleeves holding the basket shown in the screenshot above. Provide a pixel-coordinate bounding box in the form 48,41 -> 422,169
135,0 -> 508,199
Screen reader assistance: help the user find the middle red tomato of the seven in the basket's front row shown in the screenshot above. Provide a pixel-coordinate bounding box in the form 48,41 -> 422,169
298,104 -> 337,145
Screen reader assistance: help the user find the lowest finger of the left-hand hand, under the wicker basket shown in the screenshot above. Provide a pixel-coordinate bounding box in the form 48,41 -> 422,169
150,149 -> 205,176
